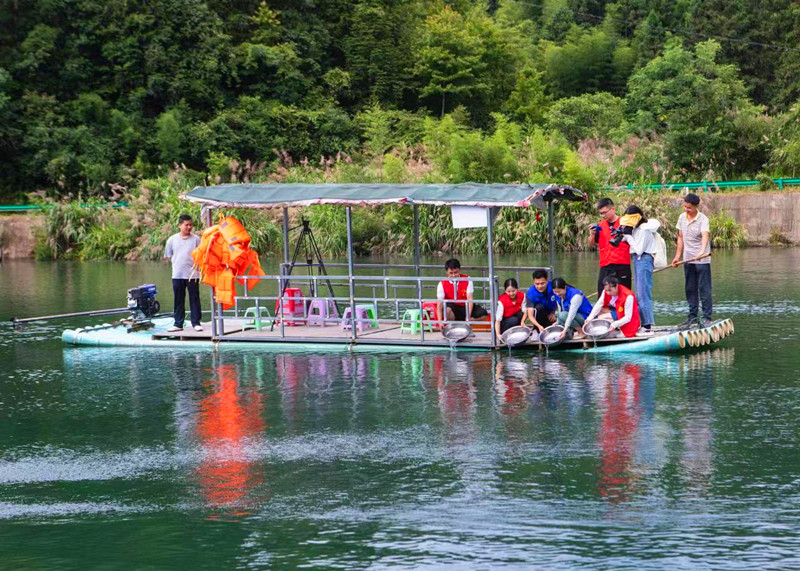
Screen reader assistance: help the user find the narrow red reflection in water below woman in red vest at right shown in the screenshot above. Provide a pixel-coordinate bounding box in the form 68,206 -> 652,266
598,364 -> 642,501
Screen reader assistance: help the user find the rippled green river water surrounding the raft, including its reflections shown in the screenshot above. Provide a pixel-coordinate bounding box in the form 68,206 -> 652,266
0,249 -> 800,569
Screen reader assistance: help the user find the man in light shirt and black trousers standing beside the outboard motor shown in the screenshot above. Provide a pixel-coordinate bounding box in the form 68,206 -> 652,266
164,214 -> 203,331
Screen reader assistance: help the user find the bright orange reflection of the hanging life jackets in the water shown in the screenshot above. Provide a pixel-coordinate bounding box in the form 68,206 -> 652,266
197,365 -> 265,514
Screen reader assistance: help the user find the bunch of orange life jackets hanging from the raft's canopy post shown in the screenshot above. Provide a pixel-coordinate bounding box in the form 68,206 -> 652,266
192,216 -> 264,309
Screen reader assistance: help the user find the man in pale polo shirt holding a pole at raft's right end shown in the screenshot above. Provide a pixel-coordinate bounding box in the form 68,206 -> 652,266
672,193 -> 712,327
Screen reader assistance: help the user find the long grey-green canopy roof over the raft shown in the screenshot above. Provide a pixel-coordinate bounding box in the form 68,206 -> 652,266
188,182 -> 585,208
